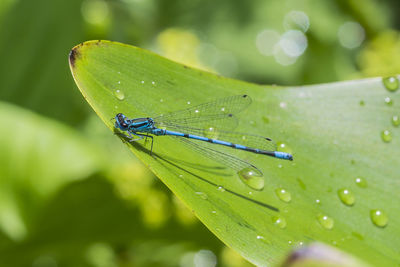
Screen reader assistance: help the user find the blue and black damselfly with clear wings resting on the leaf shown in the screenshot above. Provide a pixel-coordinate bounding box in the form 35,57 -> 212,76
115,95 -> 293,173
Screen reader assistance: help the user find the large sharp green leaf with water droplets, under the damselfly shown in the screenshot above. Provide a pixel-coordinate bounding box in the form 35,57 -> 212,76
70,41 -> 400,266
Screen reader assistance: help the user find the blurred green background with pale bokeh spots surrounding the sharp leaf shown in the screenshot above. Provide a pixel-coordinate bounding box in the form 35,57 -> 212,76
0,0 -> 400,267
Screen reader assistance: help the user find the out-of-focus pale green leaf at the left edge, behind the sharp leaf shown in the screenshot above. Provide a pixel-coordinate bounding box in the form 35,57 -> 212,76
0,102 -> 103,240
